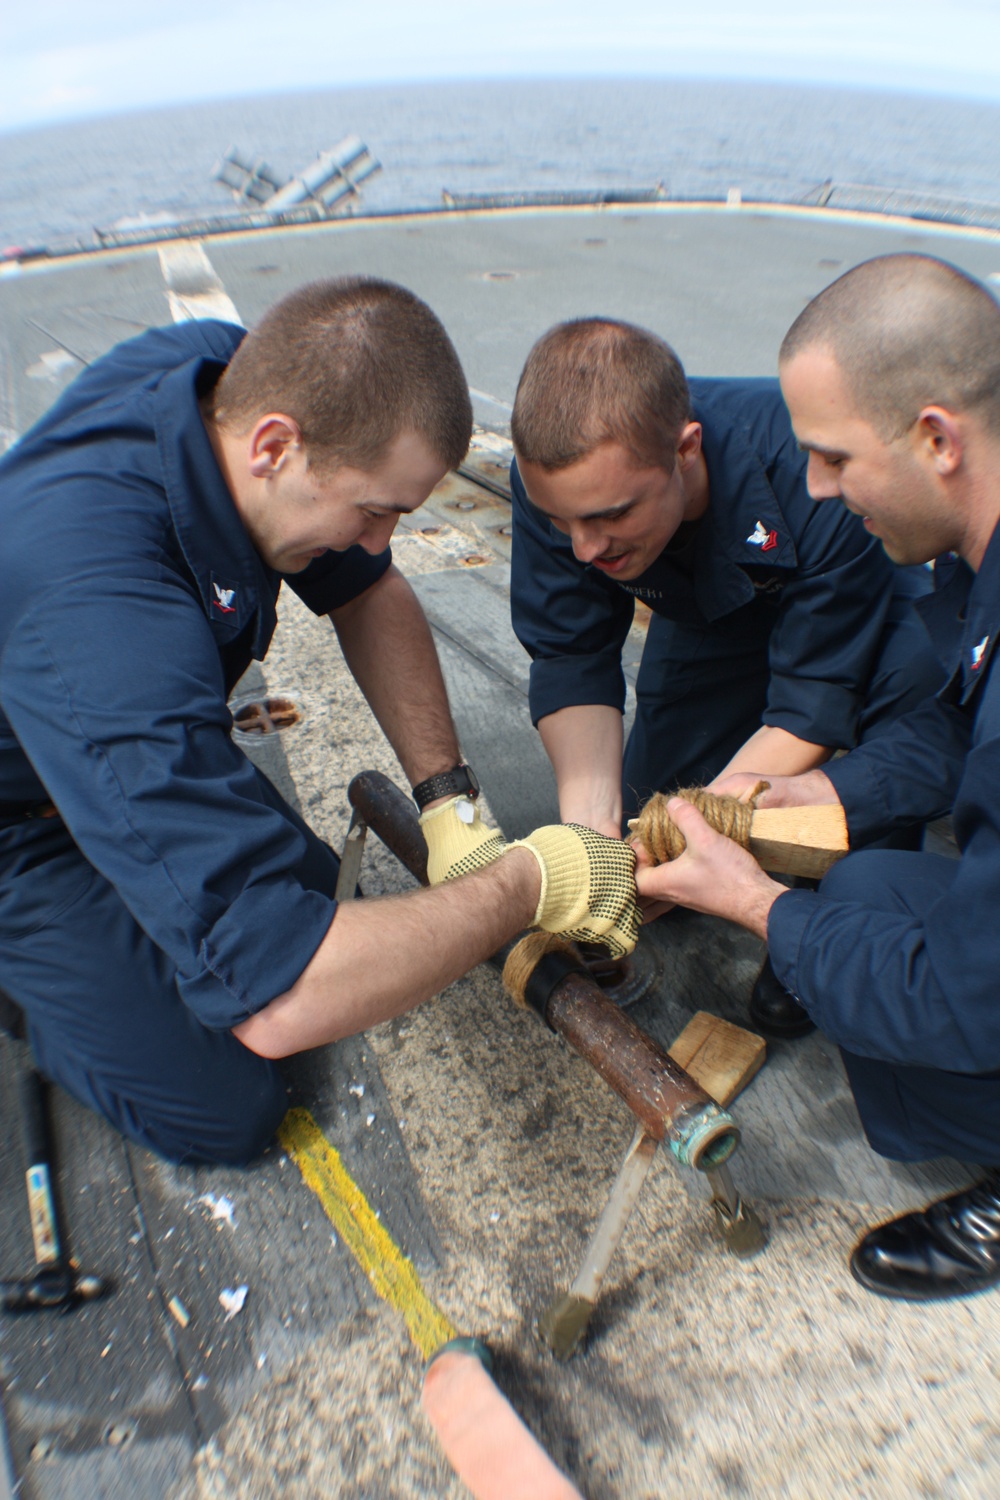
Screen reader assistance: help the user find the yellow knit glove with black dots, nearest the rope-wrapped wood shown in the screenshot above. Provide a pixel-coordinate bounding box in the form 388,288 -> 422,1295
508,824 -> 642,959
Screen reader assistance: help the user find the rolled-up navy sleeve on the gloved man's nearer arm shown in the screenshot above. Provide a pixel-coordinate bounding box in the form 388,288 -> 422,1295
0,569 -> 336,1029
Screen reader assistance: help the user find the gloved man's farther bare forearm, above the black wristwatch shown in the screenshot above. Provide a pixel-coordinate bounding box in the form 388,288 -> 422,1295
330,567 -> 460,786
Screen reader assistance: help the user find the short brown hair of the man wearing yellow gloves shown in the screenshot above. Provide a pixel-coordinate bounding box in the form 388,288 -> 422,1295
211,276 -> 472,468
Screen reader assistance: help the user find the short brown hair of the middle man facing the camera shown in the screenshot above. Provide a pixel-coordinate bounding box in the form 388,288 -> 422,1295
510,318 -> 691,470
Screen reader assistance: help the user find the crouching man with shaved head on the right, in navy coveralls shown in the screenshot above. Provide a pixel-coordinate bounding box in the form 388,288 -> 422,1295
639,255 -> 1000,1301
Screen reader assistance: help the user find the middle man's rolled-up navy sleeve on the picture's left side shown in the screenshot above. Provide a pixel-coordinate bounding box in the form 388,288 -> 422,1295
510,464 -> 636,725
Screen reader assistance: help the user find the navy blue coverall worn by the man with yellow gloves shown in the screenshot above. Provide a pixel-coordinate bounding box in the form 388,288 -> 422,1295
0,323 -> 380,1160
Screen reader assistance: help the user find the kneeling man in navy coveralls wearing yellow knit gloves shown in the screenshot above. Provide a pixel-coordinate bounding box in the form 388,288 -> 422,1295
0,301 -> 639,1163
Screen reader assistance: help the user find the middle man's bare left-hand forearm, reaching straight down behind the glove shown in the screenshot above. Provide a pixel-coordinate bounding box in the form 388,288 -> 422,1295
538,704 -> 622,839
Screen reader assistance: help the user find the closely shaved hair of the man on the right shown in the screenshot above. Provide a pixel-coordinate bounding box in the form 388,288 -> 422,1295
780,255 -> 1000,441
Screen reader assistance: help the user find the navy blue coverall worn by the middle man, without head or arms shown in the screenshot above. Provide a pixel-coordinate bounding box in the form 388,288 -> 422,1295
511,380 -> 940,818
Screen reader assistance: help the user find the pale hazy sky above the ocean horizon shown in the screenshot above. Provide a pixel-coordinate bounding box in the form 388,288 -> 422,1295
0,0 -> 1000,131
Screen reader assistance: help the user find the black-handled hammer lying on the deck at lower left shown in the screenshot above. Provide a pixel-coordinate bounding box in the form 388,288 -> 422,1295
0,1064 -> 108,1313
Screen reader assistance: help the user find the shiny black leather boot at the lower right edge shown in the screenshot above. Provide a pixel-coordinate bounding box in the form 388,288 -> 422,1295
850,1167 -> 1000,1302
